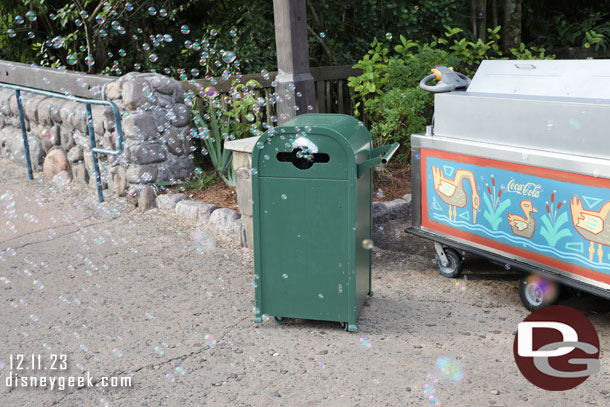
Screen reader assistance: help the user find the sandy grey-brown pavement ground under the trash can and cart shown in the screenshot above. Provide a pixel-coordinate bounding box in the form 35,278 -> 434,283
0,160 -> 610,407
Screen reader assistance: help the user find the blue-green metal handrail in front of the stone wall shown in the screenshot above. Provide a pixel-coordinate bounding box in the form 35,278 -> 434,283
0,82 -> 124,203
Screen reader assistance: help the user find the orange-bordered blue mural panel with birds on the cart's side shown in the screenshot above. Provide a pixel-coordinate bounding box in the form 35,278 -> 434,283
421,149 -> 610,284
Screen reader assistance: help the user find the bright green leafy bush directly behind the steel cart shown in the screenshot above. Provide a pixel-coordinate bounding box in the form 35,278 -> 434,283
348,27 -> 552,166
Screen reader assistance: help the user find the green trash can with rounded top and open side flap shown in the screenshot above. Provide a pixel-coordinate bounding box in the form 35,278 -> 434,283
252,114 -> 398,331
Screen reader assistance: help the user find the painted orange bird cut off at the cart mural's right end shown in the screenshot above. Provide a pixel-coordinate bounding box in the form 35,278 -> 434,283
570,195 -> 610,263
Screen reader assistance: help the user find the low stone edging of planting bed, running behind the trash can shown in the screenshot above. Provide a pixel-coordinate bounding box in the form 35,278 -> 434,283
155,194 -> 411,247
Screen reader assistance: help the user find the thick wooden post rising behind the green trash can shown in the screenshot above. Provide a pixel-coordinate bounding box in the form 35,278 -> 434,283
273,0 -> 316,124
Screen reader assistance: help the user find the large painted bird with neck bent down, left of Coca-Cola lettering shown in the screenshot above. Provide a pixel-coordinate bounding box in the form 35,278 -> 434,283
432,165 -> 481,225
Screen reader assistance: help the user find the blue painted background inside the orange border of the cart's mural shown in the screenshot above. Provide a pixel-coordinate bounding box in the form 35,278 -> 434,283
426,157 -> 610,274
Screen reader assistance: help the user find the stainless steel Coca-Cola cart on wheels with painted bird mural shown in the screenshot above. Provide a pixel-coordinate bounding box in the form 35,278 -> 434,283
408,60 -> 610,309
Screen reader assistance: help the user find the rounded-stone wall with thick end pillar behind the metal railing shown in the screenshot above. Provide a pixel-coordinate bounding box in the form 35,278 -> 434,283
0,73 -> 193,205
